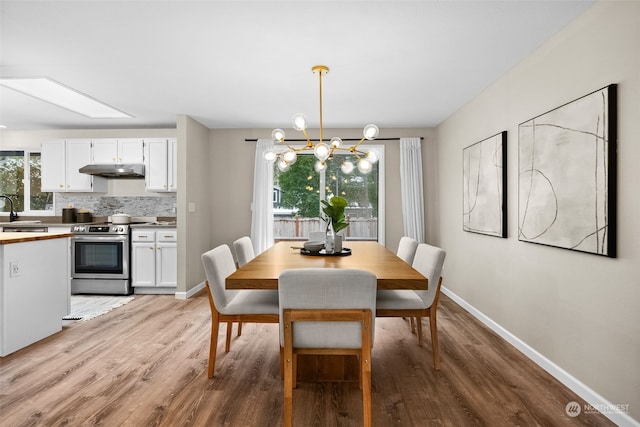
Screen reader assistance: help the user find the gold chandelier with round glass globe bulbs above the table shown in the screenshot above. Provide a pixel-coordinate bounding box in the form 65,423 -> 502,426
264,65 -> 380,174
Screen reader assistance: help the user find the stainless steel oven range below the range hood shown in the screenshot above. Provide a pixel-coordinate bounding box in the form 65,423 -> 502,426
71,224 -> 132,295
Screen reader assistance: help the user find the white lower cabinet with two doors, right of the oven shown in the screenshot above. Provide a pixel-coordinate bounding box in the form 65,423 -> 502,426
131,228 -> 178,293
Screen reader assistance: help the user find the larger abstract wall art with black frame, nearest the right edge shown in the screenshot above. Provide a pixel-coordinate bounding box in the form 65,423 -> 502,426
518,84 -> 617,258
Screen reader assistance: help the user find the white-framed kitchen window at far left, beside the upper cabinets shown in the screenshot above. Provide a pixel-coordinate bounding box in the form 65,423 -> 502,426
0,150 -> 53,215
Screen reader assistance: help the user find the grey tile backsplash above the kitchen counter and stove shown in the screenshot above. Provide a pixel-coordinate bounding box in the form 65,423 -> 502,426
56,193 -> 176,216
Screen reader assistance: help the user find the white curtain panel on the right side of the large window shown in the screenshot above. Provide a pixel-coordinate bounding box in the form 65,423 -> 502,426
400,138 -> 424,243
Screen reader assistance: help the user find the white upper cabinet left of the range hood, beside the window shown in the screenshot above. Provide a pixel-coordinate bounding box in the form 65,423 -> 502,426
41,139 -> 107,193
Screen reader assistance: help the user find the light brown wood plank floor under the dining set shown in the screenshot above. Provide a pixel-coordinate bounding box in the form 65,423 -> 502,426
0,292 -> 613,427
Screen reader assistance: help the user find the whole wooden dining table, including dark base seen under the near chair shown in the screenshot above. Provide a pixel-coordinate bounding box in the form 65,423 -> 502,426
225,240 -> 428,382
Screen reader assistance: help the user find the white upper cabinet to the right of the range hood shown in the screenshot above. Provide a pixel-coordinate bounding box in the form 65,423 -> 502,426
144,138 -> 178,192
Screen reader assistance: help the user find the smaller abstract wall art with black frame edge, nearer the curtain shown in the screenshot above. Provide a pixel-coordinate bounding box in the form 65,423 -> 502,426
462,131 -> 507,237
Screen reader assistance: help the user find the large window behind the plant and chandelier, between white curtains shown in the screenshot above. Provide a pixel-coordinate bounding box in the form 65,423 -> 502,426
273,146 -> 384,243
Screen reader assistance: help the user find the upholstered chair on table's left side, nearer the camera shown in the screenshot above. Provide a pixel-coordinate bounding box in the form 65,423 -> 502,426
201,245 -> 279,378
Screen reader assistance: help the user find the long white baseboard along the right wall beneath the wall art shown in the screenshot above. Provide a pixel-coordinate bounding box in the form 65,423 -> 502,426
441,286 -> 640,427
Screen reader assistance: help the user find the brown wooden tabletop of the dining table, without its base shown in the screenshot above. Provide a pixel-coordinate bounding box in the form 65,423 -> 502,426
225,241 -> 428,290
